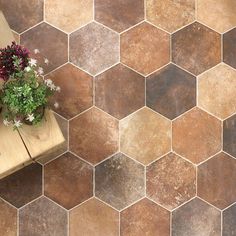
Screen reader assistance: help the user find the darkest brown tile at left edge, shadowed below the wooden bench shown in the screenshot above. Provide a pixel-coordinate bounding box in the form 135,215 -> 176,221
0,164 -> 42,207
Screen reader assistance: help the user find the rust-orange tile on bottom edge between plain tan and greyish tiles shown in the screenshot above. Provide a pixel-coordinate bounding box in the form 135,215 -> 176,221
120,198 -> 170,236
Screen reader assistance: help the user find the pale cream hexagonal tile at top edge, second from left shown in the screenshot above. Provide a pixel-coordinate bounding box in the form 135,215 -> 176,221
45,0 -> 93,33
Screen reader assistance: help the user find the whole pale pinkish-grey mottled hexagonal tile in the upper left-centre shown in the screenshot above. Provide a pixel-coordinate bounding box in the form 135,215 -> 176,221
70,22 -> 120,75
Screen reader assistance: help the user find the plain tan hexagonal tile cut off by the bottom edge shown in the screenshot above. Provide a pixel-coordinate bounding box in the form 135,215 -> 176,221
70,198 -> 119,236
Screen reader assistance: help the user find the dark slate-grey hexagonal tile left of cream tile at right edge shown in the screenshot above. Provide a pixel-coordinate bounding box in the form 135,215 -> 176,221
146,64 -> 196,119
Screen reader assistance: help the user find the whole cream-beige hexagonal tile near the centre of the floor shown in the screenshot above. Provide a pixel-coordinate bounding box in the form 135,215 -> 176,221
120,108 -> 171,164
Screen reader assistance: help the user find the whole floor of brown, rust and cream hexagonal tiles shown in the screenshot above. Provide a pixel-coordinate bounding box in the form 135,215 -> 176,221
0,0 -> 236,236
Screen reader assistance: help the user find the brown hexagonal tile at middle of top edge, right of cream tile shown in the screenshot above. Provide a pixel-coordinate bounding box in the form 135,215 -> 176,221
94,0 -> 144,32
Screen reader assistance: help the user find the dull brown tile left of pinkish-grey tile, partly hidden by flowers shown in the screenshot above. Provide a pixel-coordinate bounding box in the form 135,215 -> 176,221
21,23 -> 68,73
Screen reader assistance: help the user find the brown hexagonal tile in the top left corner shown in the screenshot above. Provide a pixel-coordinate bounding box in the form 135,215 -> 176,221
0,0 -> 43,33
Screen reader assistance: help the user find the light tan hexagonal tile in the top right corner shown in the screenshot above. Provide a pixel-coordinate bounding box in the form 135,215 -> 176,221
197,0 -> 236,33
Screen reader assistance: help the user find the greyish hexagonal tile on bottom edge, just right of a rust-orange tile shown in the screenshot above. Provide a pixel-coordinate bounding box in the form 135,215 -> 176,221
172,198 -> 221,236
